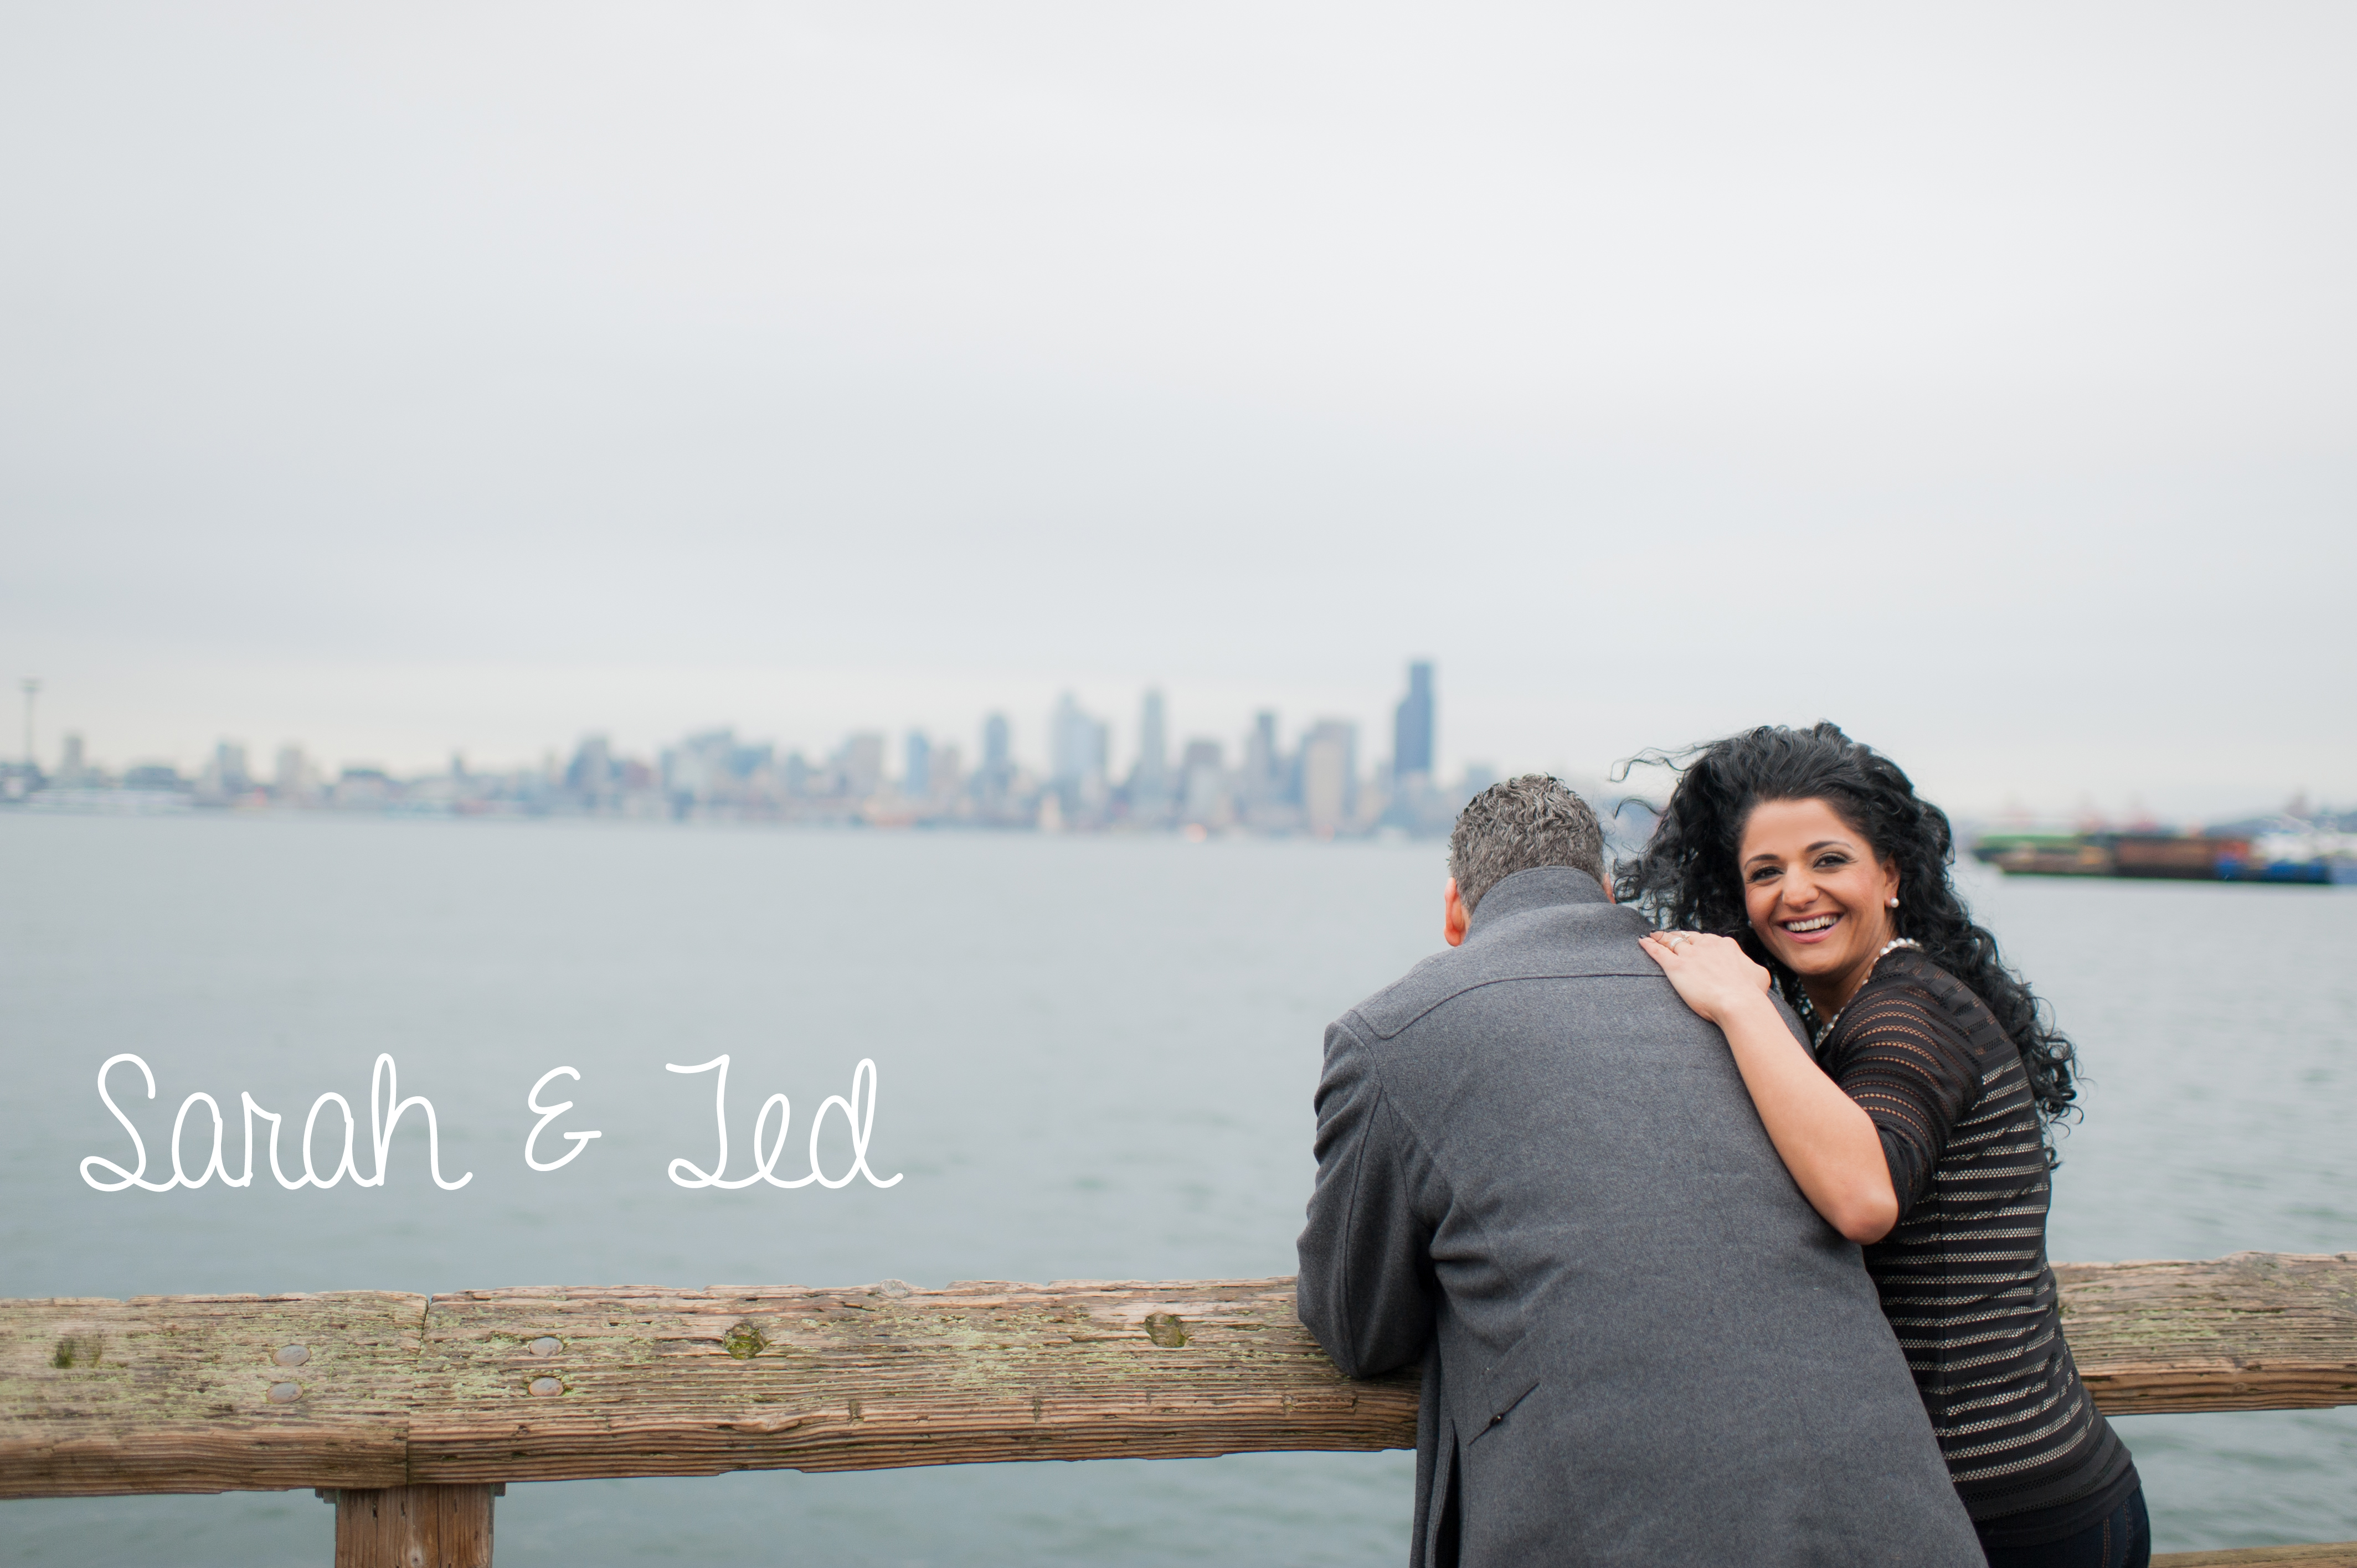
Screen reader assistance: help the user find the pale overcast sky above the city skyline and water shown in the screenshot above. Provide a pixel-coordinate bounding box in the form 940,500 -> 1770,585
0,0 -> 2357,813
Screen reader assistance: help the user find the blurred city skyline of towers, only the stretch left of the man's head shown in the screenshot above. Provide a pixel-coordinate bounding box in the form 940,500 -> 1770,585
0,660 -> 1497,839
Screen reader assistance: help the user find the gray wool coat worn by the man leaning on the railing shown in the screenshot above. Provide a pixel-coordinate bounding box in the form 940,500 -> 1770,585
1301,868 -> 1982,1568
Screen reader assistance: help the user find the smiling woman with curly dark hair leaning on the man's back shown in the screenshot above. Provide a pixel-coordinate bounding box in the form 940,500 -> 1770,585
1617,724 -> 2152,1568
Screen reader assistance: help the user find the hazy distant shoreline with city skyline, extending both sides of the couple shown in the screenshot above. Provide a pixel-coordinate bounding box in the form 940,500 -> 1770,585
0,658 -> 2338,837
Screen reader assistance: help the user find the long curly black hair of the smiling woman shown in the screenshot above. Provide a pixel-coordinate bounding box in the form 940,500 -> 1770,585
1612,724 -> 2079,1136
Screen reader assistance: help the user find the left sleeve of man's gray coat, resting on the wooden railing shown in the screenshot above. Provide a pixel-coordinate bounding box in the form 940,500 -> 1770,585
1299,1021 -> 1438,1377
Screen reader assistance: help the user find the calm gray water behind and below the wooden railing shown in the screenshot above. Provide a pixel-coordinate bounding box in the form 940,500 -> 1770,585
0,813 -> 2357,1568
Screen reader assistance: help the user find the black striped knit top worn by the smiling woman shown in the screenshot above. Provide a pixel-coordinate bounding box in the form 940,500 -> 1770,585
1817,948 -> 2135,1544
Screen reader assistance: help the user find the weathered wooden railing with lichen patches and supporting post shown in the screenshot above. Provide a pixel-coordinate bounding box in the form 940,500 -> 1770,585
0,1252 -> 2357,1568
